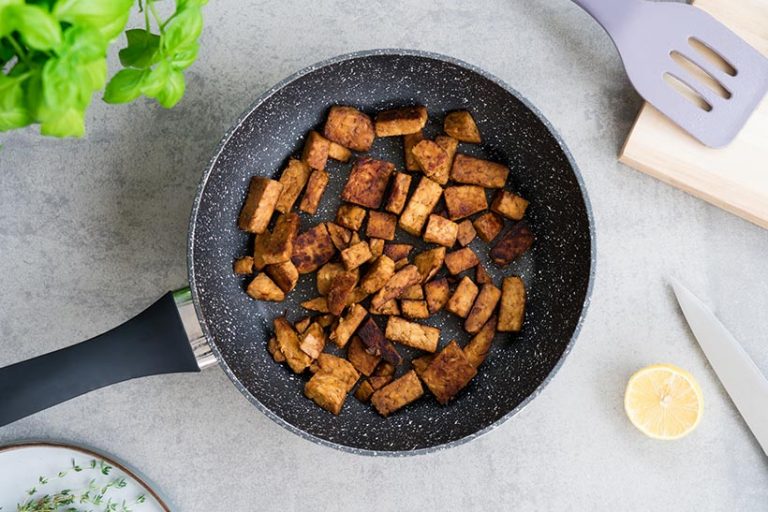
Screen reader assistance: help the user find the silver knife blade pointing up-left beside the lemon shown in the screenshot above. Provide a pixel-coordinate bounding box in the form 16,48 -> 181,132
670,279 -> 768,455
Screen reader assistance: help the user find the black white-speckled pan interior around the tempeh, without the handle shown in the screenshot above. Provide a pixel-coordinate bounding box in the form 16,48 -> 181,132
190,52 -> 592,452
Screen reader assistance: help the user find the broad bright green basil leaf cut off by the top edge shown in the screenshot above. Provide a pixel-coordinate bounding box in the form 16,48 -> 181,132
53,0 -> 133,39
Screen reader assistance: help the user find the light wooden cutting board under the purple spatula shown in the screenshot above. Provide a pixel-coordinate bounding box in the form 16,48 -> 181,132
619,0 -> 768,228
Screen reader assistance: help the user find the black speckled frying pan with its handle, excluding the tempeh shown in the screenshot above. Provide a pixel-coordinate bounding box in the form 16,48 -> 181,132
0,50 -> 594,454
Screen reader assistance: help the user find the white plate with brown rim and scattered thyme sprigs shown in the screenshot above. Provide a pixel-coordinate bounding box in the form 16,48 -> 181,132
0,443 -> 170,512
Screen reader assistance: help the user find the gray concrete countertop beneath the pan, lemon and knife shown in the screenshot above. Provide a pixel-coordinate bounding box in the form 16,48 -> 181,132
0,0 -> 768,511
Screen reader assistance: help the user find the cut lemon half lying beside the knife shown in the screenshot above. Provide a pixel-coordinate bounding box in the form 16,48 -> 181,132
624,364 -> 704,440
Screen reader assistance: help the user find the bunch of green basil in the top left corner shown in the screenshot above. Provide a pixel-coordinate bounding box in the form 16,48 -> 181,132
0,0 -> 207,137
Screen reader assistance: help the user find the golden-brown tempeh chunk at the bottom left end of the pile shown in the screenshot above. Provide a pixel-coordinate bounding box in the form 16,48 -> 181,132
304,354 -> 359,415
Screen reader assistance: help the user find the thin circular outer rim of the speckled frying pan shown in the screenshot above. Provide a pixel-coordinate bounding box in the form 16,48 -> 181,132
187,48 -> 597,457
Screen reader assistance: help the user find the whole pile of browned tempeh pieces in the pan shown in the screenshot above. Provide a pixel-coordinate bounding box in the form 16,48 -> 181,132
234,106 -> 533,416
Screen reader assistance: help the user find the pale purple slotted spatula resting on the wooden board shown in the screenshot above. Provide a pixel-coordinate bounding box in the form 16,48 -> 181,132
574,0 -> 768,147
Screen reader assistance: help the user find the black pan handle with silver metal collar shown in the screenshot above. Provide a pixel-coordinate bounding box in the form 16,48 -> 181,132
0,288 -> 215,426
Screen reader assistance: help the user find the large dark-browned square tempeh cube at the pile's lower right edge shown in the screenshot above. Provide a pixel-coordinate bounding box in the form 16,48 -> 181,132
421,340 -> 477,405
